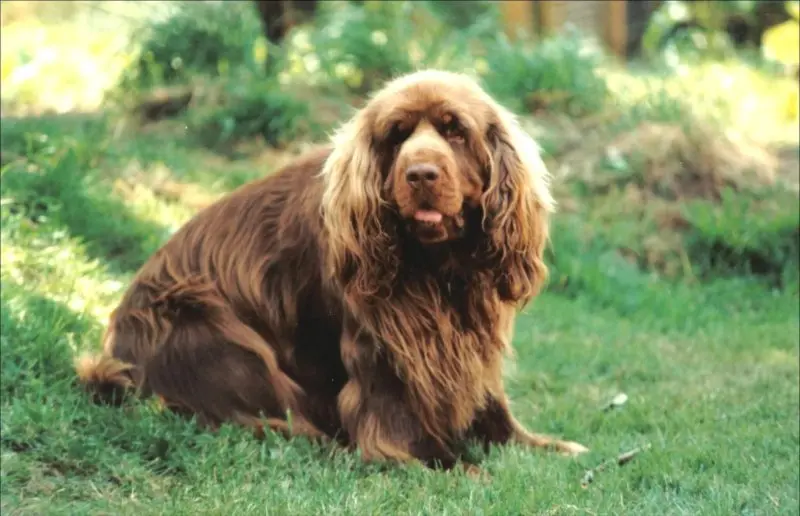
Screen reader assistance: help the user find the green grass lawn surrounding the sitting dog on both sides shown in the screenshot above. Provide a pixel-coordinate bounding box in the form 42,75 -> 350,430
0,110 -> 800,515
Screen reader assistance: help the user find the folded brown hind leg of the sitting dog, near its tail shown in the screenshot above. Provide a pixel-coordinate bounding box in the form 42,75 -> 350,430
131,305 -> 324,439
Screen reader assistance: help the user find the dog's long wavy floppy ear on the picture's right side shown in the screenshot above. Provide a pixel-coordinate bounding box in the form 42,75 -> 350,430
483,106 -> 555,304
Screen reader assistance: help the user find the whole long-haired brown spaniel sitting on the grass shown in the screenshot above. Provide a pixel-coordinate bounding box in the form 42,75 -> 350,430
77,71 -> 585,467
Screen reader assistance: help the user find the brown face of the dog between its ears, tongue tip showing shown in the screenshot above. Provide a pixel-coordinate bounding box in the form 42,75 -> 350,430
371,83 -> 491,244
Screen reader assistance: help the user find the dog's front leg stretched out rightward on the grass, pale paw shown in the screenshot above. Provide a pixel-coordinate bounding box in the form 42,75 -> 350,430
469,398 -> 589,455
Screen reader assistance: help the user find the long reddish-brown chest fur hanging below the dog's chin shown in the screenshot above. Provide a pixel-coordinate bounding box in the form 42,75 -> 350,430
379,274 -> 505,439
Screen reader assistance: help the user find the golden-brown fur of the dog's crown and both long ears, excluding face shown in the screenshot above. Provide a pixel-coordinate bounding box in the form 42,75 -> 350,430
322,67 -> 554,302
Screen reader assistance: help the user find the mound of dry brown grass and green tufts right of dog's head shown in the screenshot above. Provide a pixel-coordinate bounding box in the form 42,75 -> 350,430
554,105 -> 800,289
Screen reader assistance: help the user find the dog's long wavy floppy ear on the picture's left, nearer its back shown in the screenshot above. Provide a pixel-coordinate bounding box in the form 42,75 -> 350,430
321,110 -> 398,301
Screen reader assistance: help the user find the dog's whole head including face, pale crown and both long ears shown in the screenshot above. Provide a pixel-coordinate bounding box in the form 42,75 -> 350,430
322,71 -> 553,301
